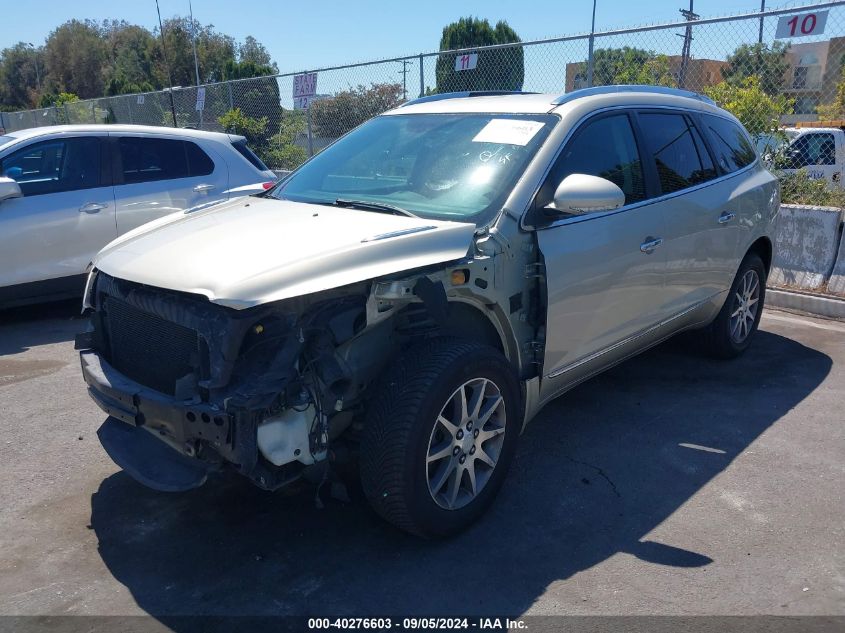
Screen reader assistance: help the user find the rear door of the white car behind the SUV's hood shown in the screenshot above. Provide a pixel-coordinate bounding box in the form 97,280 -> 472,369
112,134 -> 228,235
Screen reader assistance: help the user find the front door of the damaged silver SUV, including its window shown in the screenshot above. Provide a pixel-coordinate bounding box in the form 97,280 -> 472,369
535,111 -> 666,382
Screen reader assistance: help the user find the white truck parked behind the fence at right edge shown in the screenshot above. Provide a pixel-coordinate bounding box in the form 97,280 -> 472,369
764,120 -> 845,187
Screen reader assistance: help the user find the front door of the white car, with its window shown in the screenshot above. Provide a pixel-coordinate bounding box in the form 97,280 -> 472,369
0,134 -> 117,291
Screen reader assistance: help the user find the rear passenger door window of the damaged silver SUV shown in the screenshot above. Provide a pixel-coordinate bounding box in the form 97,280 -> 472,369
640,113 -> 716,193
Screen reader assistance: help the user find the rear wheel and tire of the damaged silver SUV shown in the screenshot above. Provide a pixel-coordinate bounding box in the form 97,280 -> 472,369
704,253 -> 766,359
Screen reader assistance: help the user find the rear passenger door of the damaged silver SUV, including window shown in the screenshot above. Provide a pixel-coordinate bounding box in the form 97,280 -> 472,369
637,109 -> 740,316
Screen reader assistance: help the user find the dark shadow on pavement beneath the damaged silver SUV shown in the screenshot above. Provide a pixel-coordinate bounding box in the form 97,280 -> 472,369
91,332 -> 831,616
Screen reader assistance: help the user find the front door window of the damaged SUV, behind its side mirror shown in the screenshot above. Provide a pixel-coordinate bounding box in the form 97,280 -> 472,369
537,114 -> 646,207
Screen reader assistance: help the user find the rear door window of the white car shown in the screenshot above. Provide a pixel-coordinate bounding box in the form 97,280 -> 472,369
118,137 -> 188,184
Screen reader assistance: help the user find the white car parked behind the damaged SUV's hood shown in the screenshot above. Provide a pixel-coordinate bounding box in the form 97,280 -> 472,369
0,125 -> 276,307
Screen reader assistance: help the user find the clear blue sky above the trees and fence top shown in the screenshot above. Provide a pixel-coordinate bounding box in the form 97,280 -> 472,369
0,0 -> 805,72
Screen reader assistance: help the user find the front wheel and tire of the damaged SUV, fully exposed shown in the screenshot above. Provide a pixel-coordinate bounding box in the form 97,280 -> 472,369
361,338 -> 522,537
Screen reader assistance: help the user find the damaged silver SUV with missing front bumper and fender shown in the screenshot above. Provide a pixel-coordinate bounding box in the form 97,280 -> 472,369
77,86 -> 779,536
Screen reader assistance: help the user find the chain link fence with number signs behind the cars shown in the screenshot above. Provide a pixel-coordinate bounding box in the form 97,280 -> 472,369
0,1 -> 845,169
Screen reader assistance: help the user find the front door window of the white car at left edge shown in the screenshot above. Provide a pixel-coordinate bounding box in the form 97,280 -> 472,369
0,137 -> 100,196
